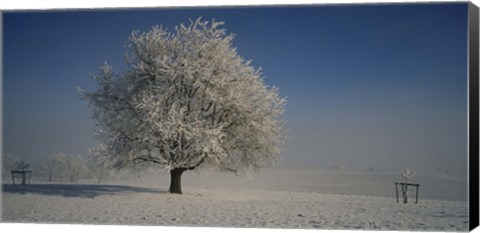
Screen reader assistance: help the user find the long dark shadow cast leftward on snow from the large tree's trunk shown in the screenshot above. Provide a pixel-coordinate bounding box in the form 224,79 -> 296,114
2,184 -> 167,198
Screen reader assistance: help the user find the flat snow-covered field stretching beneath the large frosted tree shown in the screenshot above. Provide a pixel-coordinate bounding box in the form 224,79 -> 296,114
2,169 -> 468,231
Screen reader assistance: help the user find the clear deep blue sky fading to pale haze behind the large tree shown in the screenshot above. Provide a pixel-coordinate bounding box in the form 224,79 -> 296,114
2,3 -> 467,172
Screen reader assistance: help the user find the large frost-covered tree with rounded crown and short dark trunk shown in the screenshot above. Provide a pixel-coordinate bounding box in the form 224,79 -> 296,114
80,19 -> 286,193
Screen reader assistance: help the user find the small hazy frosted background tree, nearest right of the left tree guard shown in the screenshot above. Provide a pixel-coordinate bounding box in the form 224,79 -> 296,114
37,152 -> 67,181
